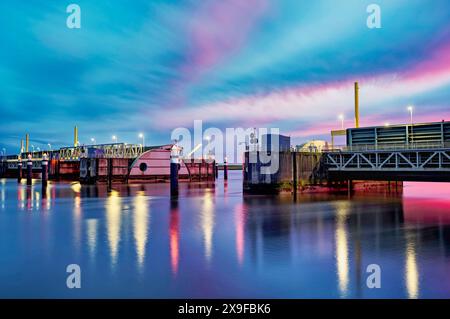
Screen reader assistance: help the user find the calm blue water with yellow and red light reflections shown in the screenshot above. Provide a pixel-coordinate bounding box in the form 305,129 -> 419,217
0,172 -> 450,298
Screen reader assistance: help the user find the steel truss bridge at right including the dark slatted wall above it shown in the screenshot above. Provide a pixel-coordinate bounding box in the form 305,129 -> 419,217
322,121 -> 450,182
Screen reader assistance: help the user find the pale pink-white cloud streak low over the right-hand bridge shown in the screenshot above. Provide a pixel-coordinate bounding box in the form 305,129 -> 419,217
154,41 -> 450,136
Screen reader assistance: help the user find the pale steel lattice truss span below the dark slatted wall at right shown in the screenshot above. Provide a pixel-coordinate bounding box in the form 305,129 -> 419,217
322,143 -> 450,182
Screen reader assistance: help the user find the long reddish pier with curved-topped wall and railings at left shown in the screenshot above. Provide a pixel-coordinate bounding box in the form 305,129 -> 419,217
0,134 -> 216,184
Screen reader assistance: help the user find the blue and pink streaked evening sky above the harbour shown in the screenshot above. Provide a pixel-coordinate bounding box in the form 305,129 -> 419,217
0,0 -> 450,154
